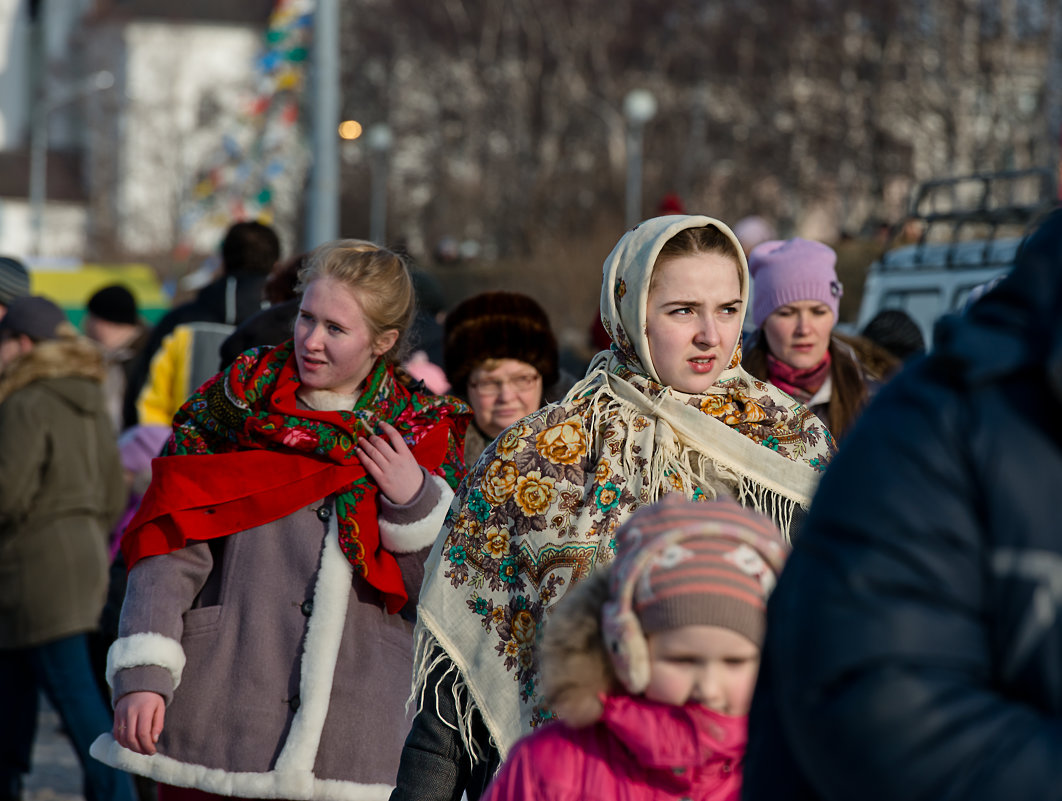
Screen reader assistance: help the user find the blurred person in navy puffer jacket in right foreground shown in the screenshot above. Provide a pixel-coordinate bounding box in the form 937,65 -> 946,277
742,211 -> 1062,801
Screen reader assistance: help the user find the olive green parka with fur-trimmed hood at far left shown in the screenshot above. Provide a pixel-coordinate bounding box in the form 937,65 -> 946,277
0,336 -> 126,648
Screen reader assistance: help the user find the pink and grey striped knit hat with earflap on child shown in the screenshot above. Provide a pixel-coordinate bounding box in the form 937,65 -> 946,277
601,494 -> 787,694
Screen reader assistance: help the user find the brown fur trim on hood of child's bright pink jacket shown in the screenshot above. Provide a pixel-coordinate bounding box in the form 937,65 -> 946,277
538,569 -> 622,727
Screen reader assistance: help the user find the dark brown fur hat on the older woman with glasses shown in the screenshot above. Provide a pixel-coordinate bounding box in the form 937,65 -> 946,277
443,292 -> 558,395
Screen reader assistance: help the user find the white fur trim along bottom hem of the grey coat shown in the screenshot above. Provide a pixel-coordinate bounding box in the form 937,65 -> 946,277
89,734 -> 394,801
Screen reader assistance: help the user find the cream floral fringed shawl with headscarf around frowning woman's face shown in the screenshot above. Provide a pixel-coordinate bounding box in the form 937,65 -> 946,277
414,217 -> 834,756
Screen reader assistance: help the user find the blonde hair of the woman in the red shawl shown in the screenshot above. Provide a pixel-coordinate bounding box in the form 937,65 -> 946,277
295,239 -> 416,364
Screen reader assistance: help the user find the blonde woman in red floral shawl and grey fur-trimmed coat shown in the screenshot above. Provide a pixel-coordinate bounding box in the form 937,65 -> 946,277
92,240 -> 470,801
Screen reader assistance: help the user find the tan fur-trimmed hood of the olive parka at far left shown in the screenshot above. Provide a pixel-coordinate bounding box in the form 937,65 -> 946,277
0,336 -> 104,411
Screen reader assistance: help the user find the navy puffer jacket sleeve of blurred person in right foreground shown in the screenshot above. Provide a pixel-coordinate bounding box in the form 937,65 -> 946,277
743,367 -> 1062,801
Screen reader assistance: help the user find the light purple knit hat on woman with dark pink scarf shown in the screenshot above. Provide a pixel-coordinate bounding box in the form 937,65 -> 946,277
749,237 -> 844,328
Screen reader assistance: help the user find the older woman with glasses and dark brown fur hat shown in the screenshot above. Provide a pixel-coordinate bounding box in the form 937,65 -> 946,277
443,292 -> 559,464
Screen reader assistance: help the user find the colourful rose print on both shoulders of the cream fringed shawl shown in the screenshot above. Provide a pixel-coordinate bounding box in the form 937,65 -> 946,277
431,354 -> 829,726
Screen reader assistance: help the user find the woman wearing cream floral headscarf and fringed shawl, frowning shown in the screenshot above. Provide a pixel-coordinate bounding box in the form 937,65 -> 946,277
392,216 -> 833,801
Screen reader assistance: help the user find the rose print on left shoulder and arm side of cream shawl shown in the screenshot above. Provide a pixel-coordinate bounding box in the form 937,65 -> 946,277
442,401 -> 640,722
